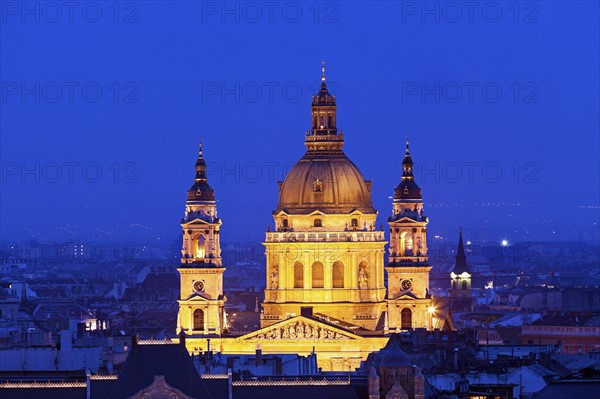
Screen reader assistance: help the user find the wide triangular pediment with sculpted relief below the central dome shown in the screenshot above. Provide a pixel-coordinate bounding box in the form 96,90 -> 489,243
240,316 -> 361,341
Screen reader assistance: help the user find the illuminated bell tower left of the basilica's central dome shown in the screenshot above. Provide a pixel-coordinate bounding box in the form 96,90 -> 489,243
177,144 -> 226,335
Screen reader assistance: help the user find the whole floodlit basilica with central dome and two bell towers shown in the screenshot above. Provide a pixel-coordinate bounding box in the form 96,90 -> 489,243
177,68 -> 449,371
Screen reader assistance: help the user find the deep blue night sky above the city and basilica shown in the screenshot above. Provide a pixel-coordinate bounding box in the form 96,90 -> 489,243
0,1 -> 600,245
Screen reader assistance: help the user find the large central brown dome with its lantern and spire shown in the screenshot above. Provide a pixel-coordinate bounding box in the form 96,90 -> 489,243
274,67 -> 376,214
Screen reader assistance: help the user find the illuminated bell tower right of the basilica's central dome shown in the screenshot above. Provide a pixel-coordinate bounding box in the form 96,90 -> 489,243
385,138 -> 434,332
